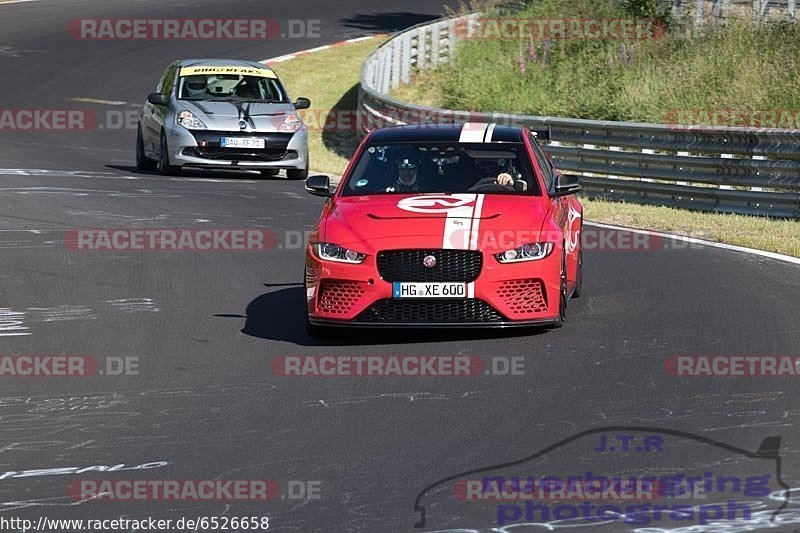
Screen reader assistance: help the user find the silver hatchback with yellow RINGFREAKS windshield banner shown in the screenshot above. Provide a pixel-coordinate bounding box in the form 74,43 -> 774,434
136,59 -> 311,179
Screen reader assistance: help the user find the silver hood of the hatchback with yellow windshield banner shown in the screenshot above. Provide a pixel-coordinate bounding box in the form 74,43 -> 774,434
177,100 -> 295,131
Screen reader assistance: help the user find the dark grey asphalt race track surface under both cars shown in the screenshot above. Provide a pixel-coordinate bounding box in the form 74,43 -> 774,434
0,0 -> 800,532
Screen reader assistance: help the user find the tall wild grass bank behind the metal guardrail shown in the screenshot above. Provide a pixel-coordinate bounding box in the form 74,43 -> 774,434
396,0 -> 800,121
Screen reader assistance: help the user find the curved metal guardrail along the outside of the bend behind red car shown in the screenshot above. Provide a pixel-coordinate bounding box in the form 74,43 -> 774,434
358,15 -> 800,219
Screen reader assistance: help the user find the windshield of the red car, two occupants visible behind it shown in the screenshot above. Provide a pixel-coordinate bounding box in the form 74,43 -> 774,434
341,142 -> 540,196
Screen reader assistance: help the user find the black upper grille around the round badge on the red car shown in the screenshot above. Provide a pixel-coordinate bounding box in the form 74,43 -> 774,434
378,250 -> 483,283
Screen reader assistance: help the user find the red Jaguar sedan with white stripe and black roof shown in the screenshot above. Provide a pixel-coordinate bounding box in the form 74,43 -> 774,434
305,123 -> 583,336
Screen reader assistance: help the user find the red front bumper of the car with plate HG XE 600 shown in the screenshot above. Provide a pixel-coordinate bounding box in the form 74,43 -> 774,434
305,249 -> 561,328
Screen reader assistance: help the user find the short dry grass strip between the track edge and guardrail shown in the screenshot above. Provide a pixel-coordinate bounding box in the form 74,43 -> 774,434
268,35 -> 800,257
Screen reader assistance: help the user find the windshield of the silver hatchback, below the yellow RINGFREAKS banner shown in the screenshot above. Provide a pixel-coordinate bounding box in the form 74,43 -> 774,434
178,74 -> 288,103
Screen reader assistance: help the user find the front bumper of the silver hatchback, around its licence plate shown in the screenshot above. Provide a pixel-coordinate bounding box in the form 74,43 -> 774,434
167,125 -> 308,170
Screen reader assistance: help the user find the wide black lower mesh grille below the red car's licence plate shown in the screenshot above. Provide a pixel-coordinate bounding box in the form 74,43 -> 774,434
355,298 -> 506,324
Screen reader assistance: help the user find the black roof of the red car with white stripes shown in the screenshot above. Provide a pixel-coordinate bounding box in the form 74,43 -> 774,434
369,122 -> 525,144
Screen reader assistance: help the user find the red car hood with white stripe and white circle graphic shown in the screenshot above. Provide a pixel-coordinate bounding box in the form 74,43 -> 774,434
320,194 -> 548,253
